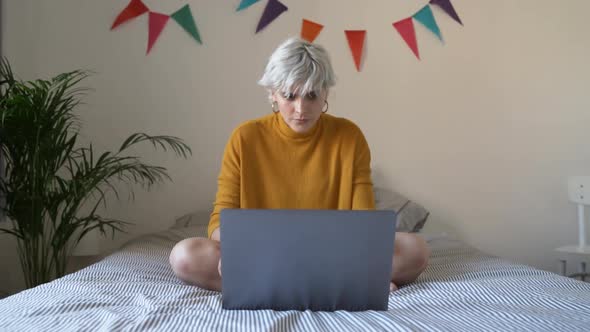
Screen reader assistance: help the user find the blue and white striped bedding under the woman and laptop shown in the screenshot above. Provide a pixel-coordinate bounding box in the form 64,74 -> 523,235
0,228 -> 590,331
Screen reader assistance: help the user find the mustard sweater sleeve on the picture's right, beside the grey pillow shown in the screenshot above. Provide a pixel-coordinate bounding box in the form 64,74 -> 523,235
352,129 -> 375,210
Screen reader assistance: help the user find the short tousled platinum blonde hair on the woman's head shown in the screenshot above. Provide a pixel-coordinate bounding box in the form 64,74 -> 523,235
258,37 -> 336,95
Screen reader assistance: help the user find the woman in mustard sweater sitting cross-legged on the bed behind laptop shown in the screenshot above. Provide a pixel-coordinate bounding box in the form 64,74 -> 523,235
170,38 -> 429,291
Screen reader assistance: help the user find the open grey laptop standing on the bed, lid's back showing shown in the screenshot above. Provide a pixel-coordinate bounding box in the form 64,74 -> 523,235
220,209 -> 396,311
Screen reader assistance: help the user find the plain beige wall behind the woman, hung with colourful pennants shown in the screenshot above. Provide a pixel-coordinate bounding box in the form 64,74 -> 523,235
0,0 -> 590,290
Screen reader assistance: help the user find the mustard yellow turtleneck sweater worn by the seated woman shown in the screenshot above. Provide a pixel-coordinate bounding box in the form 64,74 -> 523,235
208,113 -> 375,237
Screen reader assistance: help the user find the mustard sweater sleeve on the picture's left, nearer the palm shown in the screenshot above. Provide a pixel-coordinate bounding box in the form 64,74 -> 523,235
207,128 -> 241,238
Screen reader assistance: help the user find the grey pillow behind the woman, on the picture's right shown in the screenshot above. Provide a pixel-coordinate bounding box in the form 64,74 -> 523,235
373,186 -> 430,232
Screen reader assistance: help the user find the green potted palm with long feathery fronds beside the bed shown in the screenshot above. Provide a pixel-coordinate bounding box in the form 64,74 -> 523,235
0,59 -> 191,288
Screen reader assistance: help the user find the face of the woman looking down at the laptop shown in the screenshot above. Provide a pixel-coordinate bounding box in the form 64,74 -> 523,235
272,90 -> 328,134
